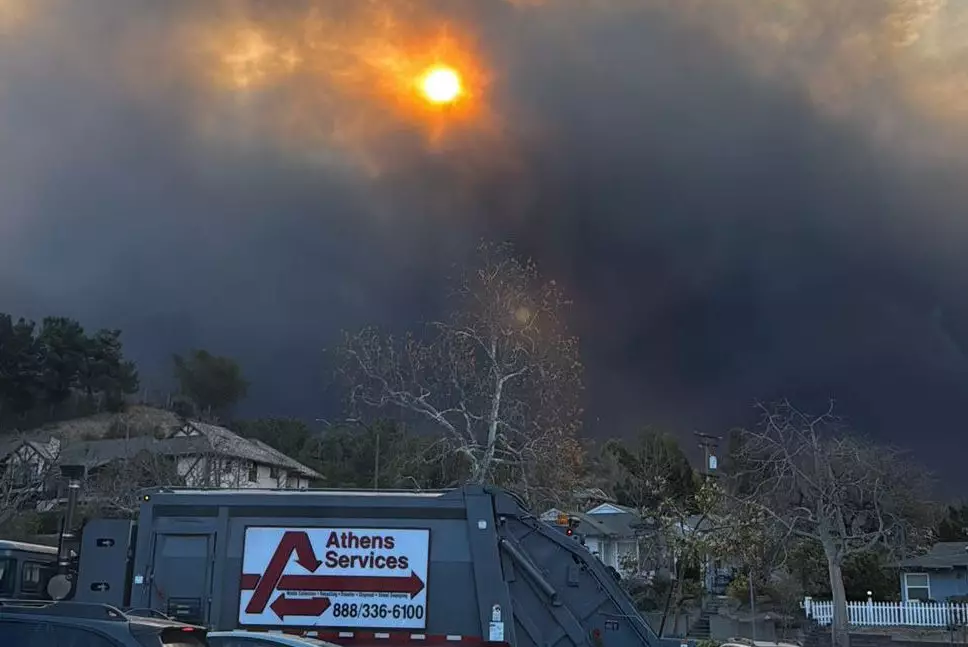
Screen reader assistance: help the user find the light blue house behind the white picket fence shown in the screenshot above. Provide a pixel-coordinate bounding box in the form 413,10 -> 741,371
898,541 -> 968,602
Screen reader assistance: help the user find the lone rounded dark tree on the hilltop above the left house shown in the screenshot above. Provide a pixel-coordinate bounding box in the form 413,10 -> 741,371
172,350 -> 249,415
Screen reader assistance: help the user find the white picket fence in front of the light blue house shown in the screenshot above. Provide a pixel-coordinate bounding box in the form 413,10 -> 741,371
803,598 -> 968,627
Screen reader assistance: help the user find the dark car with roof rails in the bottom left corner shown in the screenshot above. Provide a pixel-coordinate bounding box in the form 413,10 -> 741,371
0,600 -> 209,647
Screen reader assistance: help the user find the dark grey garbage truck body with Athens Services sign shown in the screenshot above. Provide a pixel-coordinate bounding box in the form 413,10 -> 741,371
73,486 -> 679,647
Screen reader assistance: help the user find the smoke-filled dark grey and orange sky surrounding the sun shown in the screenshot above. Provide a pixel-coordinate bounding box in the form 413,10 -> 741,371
0,0 -> 968,485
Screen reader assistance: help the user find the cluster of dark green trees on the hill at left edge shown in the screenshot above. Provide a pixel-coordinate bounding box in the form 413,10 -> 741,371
0,314 -> 138,423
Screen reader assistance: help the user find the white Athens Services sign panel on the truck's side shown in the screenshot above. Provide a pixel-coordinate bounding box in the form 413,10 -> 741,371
239,527 -> 430,629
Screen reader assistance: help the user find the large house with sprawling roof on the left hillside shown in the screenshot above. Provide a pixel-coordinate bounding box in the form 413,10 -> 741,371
0,407 -> 323,498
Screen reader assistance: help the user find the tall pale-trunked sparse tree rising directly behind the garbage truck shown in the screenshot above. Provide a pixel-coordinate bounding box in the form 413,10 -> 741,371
340,244 -> 582,503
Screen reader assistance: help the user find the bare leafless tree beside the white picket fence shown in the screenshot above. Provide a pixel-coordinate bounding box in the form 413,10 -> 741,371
734,401 -> 934,647
